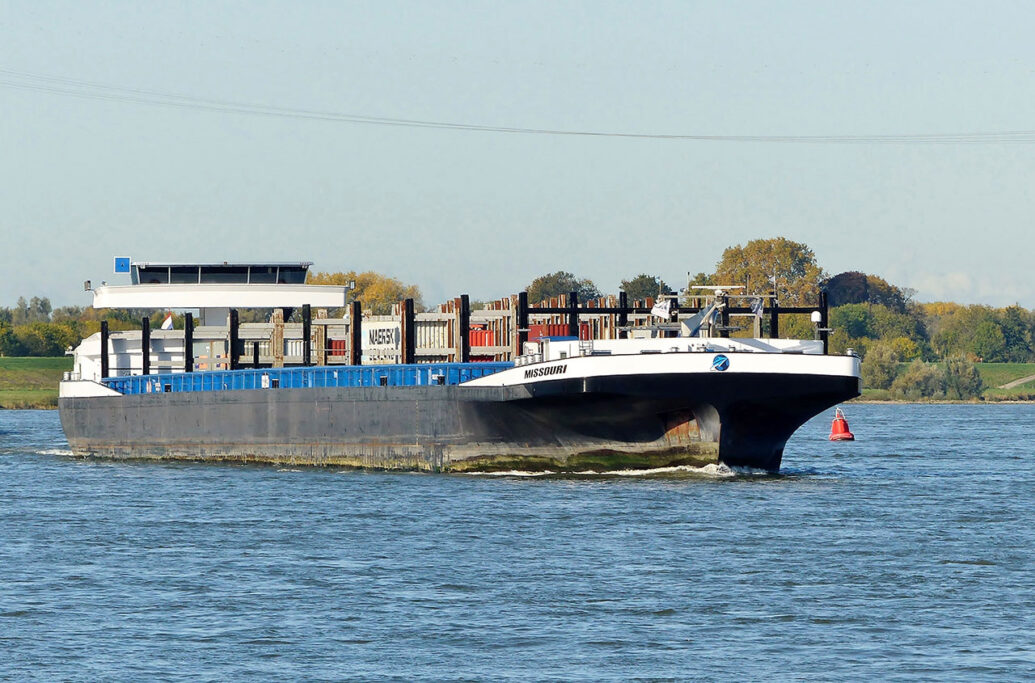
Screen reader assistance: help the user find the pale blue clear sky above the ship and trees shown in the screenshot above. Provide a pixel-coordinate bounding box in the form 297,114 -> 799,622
0,0 -> 1035,308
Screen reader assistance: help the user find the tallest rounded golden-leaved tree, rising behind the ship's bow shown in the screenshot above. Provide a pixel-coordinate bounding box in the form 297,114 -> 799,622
714,237 -> 826,306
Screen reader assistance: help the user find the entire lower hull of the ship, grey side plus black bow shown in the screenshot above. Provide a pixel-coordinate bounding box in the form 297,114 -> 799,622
59,376 -> 858,471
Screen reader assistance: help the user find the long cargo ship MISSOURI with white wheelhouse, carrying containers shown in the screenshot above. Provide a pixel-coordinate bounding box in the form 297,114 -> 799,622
59,260 -> 860,472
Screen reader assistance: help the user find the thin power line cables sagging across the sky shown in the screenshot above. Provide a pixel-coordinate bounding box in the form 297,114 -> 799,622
0,68 -> 1035,145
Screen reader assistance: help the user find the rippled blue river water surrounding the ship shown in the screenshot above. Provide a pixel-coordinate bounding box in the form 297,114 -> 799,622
0,406 -> 1035,680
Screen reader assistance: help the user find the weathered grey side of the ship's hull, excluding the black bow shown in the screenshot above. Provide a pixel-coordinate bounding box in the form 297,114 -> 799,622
60,386 -> 717,470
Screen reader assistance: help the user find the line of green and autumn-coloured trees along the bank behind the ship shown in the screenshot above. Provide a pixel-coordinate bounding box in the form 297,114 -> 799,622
6,237 -> 1035,395
